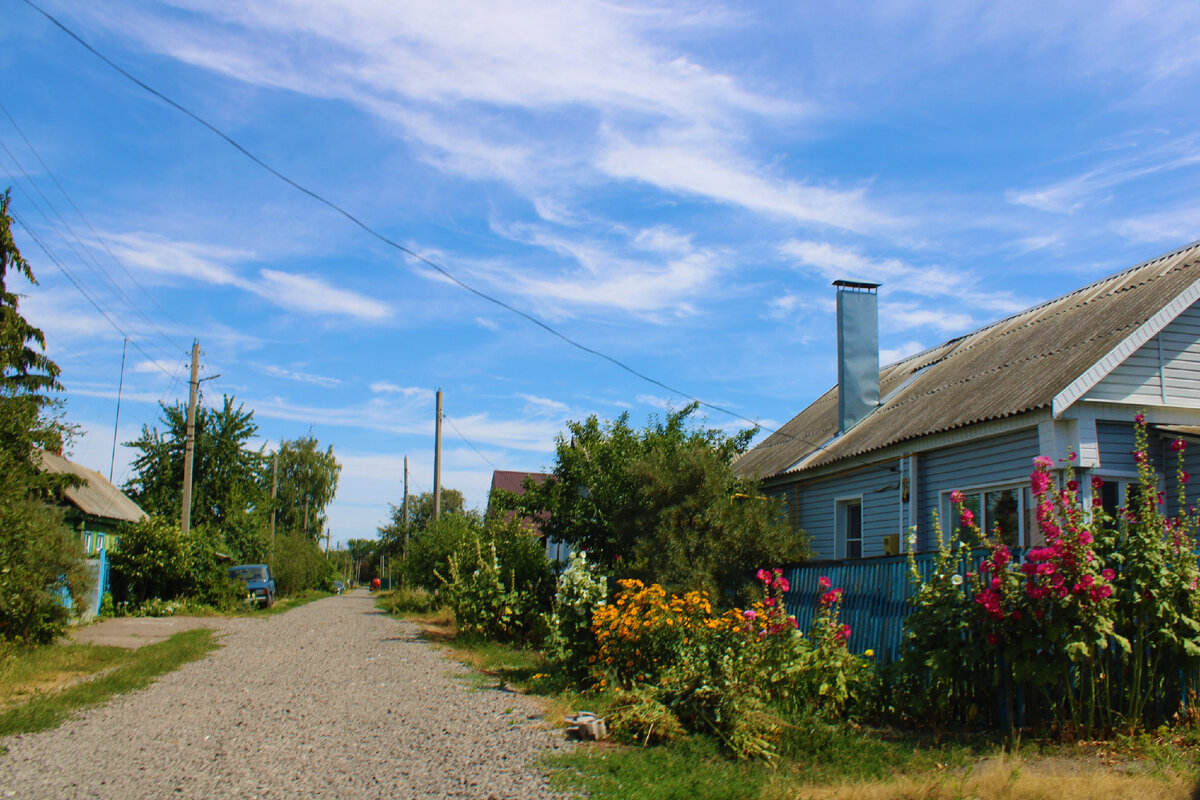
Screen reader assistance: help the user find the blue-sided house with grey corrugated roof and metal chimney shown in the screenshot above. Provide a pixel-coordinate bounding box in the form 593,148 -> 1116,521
736,243 -> 1200,561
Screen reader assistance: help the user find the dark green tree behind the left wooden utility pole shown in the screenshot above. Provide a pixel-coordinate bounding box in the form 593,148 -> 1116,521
125,395 -> 266,560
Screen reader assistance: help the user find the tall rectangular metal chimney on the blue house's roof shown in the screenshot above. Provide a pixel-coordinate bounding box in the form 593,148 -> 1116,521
833,281 -> 880,434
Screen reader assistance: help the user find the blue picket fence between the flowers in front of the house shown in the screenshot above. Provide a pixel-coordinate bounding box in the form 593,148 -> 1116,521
784,548 -> 1003,663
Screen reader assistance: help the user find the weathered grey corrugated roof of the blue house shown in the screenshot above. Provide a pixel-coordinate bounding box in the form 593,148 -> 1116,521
734,242 -> 1200,477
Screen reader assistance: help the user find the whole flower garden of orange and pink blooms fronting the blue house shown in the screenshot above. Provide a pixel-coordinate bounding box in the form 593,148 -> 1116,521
405,415 -> 1200,796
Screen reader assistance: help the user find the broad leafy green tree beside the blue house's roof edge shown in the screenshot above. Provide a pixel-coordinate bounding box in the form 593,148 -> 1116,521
493,404 -> 809,600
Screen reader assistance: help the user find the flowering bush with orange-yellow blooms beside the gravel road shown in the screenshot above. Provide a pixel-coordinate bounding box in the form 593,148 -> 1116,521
592,570 -> 870,760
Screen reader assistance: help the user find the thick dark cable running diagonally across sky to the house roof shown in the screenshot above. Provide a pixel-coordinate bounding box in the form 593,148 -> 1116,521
16,0 -> 854,462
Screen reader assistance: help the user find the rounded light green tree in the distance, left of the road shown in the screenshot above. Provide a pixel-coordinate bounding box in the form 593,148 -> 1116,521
263,435 -> 342,541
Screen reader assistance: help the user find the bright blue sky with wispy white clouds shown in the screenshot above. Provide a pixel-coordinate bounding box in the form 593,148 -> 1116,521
0,0 -> 1200,541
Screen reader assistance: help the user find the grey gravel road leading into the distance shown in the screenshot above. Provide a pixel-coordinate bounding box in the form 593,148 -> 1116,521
0,591 -> 569,800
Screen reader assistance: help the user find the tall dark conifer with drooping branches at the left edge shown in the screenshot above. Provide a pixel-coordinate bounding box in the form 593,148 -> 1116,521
0,191 -> 88,643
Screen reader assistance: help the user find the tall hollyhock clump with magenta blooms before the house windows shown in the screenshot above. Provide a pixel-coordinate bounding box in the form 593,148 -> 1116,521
902,415 -> 1200,735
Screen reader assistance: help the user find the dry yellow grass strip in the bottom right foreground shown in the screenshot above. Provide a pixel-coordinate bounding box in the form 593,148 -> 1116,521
762,759 -> 1196,800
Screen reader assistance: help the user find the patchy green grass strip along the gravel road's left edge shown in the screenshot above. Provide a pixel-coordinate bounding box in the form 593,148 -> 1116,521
0,628 -> 220,736
